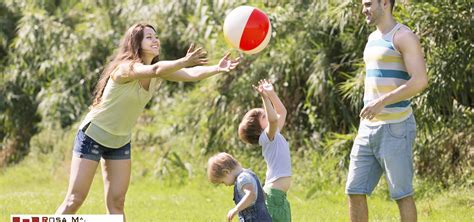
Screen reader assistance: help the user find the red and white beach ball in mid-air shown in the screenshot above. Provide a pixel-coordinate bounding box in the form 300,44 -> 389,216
224,6 -> 272,54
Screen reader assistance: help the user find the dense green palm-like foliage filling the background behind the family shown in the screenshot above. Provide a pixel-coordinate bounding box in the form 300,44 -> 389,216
0,0 -> 474,187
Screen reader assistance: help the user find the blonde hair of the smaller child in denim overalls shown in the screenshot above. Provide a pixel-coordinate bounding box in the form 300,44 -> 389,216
207,152 -> 240,183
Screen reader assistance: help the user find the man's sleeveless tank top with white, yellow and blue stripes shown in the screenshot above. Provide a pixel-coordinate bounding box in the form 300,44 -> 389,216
362,24 -> 412,125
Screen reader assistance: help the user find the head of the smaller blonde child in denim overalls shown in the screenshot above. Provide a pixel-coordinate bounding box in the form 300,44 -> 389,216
207,152 -> 240,186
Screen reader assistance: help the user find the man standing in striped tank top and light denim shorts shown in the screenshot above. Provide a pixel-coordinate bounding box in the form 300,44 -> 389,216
346,0 -> 428,221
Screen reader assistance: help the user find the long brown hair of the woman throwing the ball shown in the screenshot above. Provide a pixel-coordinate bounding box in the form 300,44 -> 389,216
92,23 -> 158,107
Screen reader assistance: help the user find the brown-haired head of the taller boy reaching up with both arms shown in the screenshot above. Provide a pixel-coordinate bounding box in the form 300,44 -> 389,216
239,108 -> 268,144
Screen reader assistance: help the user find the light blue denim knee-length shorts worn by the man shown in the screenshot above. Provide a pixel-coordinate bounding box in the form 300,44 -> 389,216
346,115 -> 416,200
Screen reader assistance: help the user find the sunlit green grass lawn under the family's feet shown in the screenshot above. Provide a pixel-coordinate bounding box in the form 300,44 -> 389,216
0,154 -> 474,222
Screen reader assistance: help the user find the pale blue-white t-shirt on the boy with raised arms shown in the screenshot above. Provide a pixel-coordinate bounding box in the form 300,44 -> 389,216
258,130 -> 292,184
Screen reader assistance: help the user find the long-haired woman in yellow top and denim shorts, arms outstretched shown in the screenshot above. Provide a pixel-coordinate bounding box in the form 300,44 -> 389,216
56,24 -> 239,219
